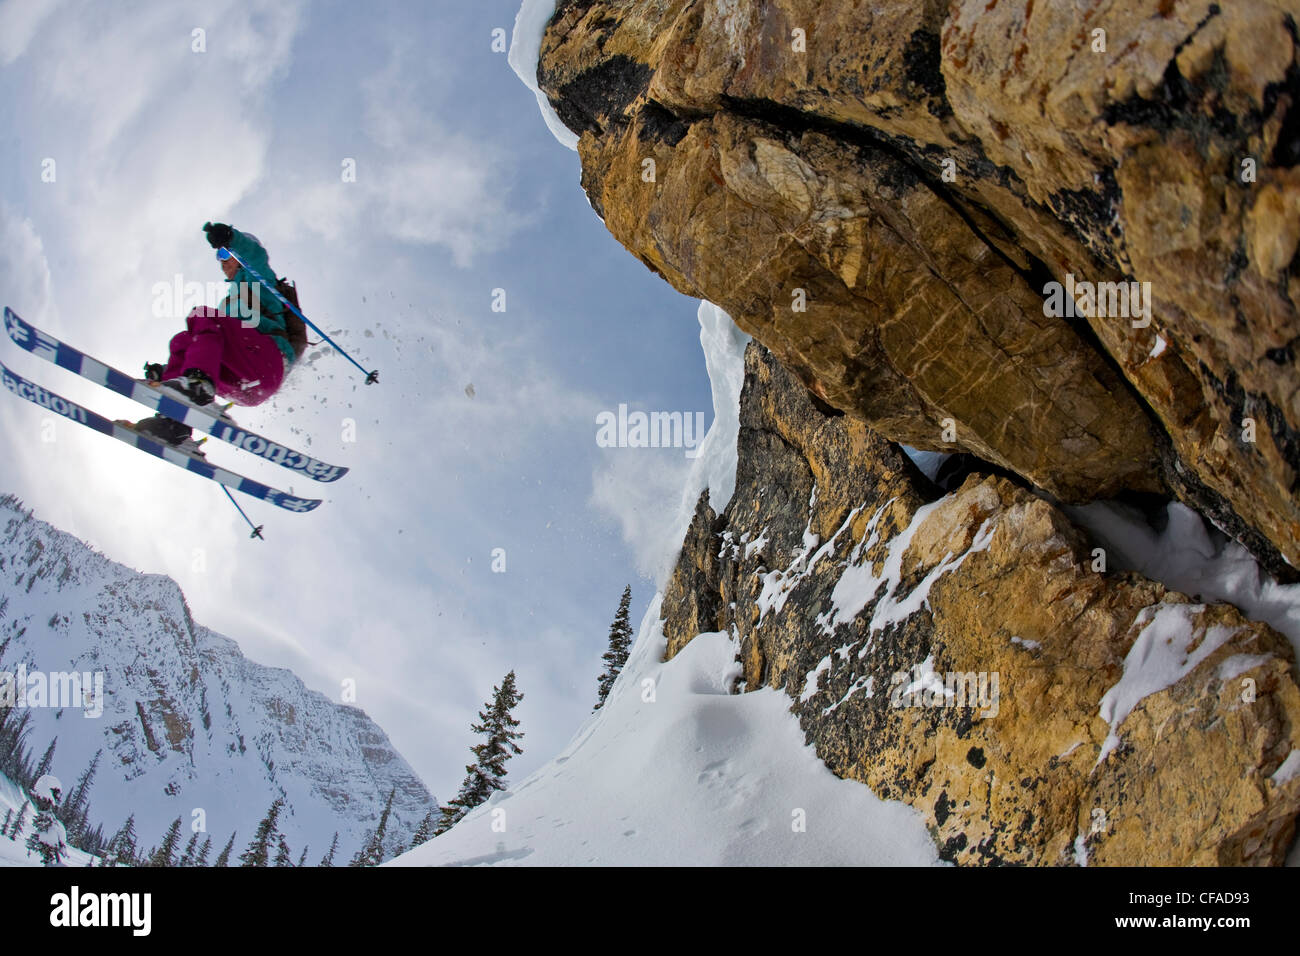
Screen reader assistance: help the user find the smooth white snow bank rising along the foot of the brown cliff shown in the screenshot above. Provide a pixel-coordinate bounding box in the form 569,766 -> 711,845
390,303 -> 937,866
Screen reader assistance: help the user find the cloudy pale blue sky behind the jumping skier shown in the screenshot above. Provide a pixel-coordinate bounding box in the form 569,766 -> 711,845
0,0 -> 711,800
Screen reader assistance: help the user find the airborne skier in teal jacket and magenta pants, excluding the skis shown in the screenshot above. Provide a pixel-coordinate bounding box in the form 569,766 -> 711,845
133,222 -> 299,446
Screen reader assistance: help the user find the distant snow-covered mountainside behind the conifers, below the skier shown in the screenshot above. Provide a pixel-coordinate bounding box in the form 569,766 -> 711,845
0,499 -> 436,864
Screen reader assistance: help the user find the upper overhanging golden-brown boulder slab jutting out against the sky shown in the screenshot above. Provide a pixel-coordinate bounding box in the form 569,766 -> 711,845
538,0 -> 1300,574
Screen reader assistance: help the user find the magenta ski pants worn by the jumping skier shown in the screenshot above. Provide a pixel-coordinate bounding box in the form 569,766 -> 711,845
163,306 -> 285,405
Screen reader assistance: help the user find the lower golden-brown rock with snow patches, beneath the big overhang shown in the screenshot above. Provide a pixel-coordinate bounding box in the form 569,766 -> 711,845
663,345 -> 1300,865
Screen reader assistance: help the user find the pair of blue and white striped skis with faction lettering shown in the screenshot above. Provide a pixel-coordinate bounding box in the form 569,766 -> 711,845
0,307 -> 347,522
